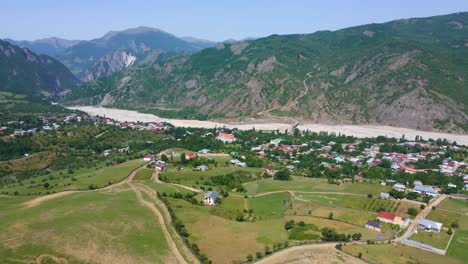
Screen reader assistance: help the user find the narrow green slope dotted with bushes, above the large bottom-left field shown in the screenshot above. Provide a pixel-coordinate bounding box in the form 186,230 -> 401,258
0,159 -> 143,194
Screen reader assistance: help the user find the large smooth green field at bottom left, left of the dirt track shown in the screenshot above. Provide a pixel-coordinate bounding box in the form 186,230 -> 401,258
0,186 -> 175,263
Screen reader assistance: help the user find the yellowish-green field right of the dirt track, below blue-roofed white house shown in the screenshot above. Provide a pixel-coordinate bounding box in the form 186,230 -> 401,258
169,199 -> 288,263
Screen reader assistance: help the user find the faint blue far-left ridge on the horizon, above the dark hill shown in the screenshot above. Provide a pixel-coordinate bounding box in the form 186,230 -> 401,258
5,37 -> 80,57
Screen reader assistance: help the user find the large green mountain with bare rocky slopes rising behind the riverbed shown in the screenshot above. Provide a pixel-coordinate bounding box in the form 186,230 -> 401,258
68,13 -> 468,133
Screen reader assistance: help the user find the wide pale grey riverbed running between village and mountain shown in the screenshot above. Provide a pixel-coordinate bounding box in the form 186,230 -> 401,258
69,106 -> 468,145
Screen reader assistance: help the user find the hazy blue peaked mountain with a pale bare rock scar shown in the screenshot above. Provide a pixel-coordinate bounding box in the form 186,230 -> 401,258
57,27 -> 213,81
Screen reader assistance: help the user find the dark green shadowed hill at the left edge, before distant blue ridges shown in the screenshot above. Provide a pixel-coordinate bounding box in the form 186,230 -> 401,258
0,40 -> 79,97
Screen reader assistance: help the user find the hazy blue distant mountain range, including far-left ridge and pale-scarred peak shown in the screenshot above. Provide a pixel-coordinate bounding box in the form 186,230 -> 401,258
6,27 -> 216,81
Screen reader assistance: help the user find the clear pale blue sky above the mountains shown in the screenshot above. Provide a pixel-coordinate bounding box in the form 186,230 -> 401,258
0,0 -> 468,41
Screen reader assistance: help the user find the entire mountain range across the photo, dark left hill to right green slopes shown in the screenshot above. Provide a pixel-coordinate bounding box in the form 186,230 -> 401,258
0,12 -> 468,134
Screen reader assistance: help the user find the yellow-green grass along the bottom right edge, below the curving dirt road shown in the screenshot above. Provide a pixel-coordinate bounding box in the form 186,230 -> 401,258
343,244 -> 463,264
